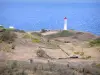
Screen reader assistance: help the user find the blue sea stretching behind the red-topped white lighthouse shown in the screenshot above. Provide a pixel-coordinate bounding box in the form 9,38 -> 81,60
0,2 -> 100,35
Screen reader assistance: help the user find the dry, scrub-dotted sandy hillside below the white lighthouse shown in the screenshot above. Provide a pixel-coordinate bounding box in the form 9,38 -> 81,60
0,30 -> 100,75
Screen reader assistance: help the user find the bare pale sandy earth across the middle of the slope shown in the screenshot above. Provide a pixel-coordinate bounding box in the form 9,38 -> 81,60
9,32 -> 100,61
